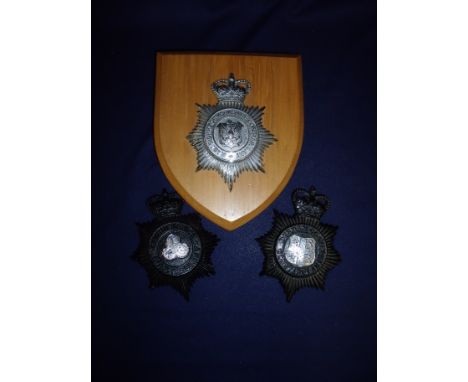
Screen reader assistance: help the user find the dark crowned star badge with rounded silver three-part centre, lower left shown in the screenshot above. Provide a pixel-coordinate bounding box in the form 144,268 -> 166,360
133,190 -> 218,300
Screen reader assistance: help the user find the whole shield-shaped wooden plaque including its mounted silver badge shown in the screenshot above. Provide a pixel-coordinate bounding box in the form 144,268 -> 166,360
154,52 -> 304,231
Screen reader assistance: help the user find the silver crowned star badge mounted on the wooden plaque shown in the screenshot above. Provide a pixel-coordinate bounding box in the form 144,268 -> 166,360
187,73 -> 277,191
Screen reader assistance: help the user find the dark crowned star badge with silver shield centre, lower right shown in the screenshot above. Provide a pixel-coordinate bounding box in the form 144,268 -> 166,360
257,187 -> 340,301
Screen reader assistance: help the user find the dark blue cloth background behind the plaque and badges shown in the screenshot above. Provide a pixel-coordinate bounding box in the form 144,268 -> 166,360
91,0 -> 376,382
